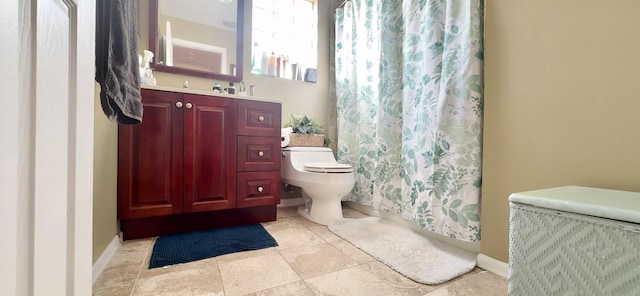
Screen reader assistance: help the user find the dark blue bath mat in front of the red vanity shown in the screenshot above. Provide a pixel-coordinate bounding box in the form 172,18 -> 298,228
149,224 -> 278,268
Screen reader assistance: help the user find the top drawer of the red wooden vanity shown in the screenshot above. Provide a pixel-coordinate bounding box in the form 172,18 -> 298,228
238,100 -> 282,138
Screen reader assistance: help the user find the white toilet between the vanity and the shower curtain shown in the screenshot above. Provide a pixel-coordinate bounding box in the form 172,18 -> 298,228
280,147 -> 356,225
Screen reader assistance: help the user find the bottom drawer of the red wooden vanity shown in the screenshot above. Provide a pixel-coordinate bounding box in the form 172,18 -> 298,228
236,171 -> 280,208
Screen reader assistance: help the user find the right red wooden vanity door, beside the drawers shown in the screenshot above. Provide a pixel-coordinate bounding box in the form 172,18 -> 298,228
183,94 -> 237,213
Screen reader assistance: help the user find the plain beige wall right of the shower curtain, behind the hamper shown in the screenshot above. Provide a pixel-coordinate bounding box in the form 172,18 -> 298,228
481,0 -> 640,262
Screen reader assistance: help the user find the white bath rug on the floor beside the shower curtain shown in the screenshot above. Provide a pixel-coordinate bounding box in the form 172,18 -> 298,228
329,217 -> 476,285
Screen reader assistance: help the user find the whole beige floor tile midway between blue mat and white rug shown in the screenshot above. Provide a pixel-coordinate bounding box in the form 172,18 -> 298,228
280,243 -> 357,279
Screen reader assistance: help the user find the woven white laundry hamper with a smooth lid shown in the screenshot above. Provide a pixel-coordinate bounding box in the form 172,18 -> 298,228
508,186 -> 640,296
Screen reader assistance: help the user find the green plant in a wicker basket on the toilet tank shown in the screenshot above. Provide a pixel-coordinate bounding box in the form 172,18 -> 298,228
285,114 -> 324,147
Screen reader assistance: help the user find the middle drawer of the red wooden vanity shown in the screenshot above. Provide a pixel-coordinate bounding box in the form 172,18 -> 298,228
238,136 -> 282,172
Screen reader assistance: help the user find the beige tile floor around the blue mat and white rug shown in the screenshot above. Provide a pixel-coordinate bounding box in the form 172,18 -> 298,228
93,208 -> 507,296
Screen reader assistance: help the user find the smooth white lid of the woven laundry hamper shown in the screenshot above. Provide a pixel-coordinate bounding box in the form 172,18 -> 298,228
509,186 -> 640,223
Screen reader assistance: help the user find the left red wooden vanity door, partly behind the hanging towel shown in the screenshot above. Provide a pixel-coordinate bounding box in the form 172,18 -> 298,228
118,89 -> 183,219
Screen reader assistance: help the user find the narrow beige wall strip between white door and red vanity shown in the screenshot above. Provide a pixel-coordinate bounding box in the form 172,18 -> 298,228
93,83 -> 118,263
